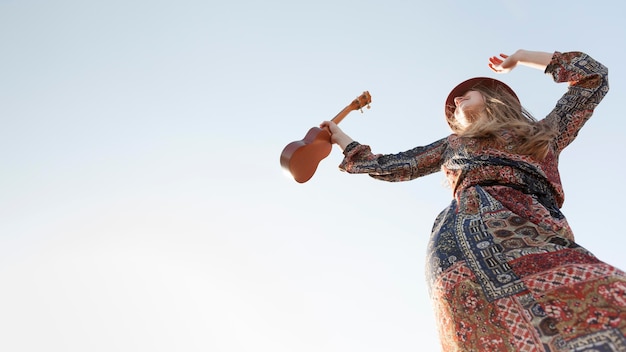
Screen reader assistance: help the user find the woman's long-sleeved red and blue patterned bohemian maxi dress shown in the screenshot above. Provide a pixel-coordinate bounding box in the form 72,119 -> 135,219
340,52 -> 626,352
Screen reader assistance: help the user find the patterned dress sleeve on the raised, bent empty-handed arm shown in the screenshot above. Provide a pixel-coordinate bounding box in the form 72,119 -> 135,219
544,51 -> 609,154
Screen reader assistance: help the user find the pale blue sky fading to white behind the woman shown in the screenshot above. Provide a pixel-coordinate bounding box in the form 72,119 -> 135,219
0,0 -> 626,352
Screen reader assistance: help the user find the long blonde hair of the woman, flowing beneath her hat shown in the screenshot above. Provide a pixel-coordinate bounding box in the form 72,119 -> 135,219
447,86 -> 556,160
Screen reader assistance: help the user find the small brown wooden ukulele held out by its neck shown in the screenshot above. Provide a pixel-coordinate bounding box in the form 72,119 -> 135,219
280,91 -> 372,183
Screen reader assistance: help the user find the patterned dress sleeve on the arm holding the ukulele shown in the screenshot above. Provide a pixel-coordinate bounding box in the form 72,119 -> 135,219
339,138 -> 448,182
